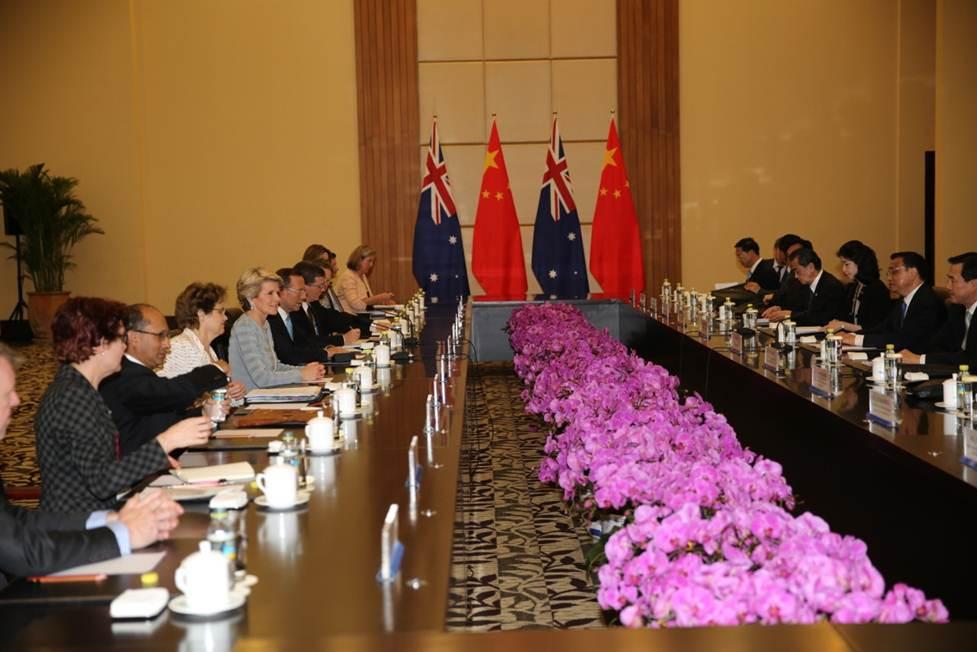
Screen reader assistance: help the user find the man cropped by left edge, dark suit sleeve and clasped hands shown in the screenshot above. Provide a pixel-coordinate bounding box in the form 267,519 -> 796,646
0,344 -> 183,588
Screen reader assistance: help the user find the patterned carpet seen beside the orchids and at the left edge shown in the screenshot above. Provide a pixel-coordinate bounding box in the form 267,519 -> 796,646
0,352 -> 603,631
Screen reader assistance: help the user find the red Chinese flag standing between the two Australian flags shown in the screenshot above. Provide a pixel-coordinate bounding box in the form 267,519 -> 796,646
472,120 -> 527,298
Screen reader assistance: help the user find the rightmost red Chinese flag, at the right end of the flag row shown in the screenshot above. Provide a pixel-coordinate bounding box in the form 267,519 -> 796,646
590,117 -> 645,299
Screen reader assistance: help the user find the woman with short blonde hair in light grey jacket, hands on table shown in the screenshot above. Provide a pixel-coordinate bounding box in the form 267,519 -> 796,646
228,267 -> 325,390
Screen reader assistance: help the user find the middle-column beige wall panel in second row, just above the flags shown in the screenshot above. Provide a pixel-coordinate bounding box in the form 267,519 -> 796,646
485,61 -> 553,145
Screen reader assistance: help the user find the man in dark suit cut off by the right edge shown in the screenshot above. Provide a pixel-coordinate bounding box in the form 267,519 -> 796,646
902,251 -> 977,366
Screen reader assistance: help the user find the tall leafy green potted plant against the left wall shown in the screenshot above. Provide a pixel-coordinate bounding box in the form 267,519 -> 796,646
0,163 -> 104,340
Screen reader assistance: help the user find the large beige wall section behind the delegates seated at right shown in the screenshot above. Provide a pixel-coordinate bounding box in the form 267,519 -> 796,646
679,0 -> 898,288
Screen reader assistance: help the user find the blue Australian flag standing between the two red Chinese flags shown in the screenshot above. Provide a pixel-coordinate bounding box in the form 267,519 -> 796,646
533,115 -> 590,299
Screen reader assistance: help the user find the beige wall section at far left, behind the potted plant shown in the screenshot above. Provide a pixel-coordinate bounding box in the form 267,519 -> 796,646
0,1 -> 145,308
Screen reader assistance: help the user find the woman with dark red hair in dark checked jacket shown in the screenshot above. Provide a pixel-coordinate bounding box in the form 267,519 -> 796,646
34,297 -> 210,512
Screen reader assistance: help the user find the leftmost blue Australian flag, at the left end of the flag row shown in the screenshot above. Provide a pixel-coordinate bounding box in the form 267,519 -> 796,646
414,118 -> 469,303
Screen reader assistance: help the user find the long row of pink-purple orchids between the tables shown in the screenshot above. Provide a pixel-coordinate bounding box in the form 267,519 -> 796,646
508,304 -> 949,627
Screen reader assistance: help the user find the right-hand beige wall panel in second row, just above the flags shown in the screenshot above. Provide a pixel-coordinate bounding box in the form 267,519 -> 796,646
553,59 -> 617,140
